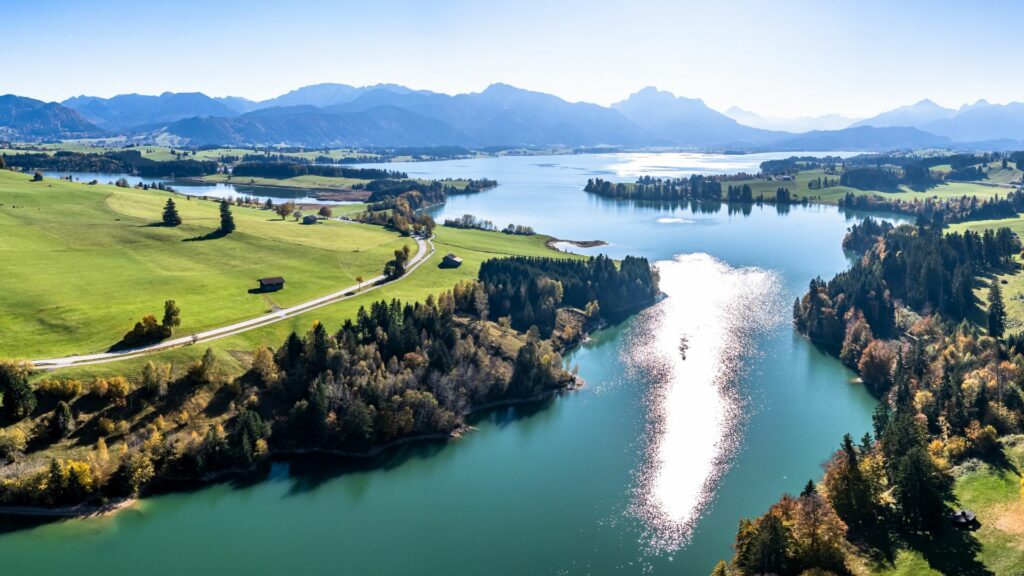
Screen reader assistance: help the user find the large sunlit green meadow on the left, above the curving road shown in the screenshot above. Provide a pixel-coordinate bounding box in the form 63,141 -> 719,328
0,171 -> 411,359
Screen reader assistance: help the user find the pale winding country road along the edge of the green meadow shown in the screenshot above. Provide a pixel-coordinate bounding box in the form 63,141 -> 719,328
32,238 -> 434,370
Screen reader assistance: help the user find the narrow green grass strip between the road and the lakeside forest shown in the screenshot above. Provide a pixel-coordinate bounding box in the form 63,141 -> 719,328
41,227 -> 581,379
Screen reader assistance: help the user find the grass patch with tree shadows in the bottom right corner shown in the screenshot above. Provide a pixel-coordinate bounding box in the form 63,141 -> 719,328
870,436 -> 1024,576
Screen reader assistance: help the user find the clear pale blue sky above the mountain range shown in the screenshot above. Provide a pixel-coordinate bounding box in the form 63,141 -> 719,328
0,0 -> 1024,116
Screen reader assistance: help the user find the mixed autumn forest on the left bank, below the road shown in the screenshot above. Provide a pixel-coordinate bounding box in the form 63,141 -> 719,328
0,256 -> 659,506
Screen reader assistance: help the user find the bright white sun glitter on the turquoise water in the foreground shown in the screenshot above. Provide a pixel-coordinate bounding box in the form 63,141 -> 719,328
624,253 -> 784,550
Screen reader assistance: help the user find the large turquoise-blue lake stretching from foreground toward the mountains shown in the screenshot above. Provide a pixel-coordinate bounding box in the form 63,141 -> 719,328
8,154 -> 888,575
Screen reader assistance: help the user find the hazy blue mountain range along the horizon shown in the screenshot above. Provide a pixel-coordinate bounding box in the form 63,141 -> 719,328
0,84 -> 1024,151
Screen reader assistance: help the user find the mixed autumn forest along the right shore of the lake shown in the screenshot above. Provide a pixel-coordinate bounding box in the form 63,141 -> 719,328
714,218 -> 1024,575
